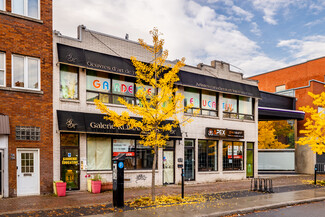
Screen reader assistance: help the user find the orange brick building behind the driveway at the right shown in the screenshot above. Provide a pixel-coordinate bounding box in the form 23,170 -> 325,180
250,57 -> 325,173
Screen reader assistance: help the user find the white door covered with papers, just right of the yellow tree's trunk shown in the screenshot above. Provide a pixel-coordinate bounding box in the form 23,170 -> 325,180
163,150 -> 174,184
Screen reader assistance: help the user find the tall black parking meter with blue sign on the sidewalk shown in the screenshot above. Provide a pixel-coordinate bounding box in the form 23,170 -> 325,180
112,154 -> 125,207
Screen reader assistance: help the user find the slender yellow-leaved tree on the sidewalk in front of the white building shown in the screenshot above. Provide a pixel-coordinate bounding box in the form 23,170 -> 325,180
95,28 -> 192,201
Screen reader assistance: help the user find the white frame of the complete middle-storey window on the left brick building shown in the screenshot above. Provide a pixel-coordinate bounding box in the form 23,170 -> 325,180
11,54 -> 41,90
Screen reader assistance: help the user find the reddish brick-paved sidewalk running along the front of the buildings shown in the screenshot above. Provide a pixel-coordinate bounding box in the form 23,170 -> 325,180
0,175 -> 325,215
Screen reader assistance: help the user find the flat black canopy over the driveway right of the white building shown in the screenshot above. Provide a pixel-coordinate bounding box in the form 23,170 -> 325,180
258,107 -> 305,121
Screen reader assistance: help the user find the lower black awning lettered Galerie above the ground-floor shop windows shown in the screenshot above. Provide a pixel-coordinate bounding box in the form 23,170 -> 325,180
57,110 -> 182,139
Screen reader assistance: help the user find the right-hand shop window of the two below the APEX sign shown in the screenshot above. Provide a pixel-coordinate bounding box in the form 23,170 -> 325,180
223,141 -> 244,171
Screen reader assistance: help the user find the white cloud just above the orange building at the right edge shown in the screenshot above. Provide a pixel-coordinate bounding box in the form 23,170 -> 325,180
277,35 -> 325,62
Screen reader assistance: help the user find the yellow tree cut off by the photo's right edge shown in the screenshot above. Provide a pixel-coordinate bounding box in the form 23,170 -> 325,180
297,92 -> 325,154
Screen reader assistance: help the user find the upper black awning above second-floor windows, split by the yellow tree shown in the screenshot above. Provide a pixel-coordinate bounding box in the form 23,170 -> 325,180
57,44 -> 260,98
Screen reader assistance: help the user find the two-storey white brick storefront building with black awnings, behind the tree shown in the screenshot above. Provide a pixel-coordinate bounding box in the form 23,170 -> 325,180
53,26 -> 260,190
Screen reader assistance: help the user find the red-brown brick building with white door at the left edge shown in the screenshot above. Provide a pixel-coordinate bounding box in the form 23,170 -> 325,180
0,0 -> 53,197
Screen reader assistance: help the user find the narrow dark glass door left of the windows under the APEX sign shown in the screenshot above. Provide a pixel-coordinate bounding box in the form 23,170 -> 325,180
184,140 -> 195,181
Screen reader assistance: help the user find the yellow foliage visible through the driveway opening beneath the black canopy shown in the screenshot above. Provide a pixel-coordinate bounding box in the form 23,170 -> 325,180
258,121 -> 289,149
